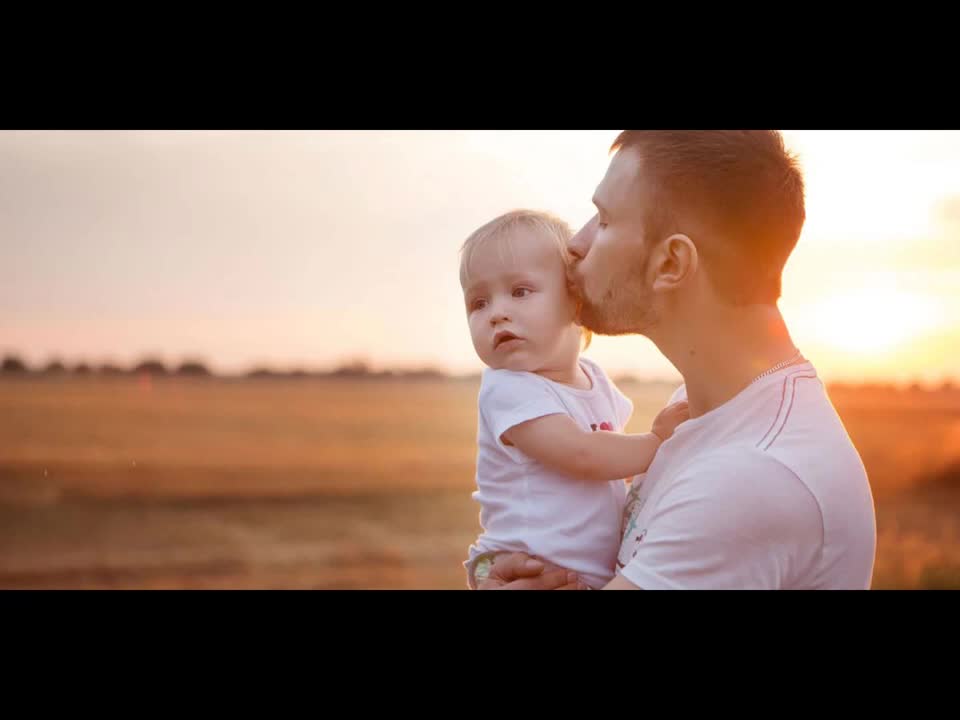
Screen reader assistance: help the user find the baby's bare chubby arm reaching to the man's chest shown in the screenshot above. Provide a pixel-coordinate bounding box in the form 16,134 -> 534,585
502,402 -> 689,482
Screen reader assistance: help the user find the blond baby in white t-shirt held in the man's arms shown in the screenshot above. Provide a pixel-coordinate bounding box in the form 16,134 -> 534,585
460,210 -> 688,588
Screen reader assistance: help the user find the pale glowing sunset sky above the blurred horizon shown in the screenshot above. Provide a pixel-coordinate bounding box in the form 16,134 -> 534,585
0,130 -> 960,382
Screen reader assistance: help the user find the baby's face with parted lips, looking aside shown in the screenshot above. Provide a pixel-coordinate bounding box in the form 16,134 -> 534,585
463,229 -> 581,372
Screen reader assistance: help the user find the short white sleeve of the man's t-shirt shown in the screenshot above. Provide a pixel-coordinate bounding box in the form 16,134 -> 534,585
621,451 -> 823,590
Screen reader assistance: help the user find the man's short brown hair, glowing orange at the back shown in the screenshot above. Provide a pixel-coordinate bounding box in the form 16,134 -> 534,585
610,130 -> 806,305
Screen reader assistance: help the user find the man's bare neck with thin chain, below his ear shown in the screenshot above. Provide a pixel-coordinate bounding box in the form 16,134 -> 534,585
653,305 -> 797,417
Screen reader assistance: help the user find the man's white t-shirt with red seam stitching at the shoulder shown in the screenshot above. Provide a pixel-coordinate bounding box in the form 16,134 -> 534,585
617,362 -> 876,589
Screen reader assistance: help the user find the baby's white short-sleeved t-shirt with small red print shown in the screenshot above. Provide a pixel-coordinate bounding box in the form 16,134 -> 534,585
465,357 -> 633,587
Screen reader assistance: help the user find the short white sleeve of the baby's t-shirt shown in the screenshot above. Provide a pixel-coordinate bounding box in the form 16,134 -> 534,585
480,370 -> 568,440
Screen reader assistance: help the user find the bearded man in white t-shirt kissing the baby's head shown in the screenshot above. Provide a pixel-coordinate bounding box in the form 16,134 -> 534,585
479,131 -> 876,590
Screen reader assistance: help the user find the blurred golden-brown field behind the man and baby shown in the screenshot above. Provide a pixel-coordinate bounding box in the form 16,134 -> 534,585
0,376 -> 960,589
